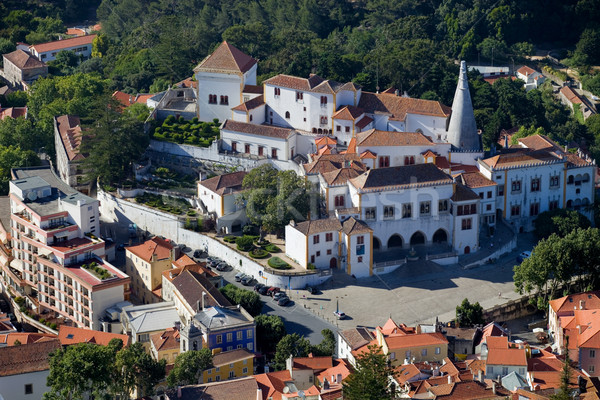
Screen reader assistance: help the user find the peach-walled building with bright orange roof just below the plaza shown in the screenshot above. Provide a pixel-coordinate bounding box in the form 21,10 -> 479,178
375,319 -> 448,367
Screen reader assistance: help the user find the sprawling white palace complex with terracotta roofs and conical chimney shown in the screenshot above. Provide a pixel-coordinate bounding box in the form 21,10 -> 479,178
190,42 -> 596,277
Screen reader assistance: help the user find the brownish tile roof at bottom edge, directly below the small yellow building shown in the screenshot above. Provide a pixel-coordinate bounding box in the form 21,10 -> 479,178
167,376 -> 258,400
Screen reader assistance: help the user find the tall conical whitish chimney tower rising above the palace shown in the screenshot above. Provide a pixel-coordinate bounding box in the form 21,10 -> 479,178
448,61 -> 481,151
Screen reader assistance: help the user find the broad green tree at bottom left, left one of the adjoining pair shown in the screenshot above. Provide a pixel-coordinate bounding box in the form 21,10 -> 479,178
43,343 -> 115,400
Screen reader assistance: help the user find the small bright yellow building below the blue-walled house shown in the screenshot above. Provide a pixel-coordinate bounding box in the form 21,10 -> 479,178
202,348 -> 254,383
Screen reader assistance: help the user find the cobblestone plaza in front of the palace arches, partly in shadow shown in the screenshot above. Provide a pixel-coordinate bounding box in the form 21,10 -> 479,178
295,234 -> 535,329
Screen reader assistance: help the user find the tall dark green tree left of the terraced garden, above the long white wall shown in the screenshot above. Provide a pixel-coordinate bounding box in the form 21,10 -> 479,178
81,97 -> 149,184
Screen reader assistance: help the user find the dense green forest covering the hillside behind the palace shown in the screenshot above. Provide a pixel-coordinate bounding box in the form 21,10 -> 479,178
0,0 -> 600,193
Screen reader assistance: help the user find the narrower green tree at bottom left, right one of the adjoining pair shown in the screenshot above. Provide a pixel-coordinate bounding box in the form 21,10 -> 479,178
113,339 -> 166,399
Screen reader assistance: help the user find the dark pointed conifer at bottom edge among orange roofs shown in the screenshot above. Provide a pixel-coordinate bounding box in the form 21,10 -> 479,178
343,345 -> 394,400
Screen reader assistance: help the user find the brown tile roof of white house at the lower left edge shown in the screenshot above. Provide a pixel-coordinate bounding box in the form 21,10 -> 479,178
0,339 -> 60,376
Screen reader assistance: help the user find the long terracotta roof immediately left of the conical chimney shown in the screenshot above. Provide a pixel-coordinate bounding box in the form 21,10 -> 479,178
358,92 -> 450,121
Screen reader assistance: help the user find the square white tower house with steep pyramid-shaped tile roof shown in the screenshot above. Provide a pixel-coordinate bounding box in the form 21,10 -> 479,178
194,41 -> 257,121
